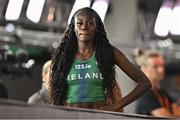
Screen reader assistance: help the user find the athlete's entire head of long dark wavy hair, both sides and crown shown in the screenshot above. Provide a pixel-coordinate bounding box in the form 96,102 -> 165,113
50,7 -> 116,105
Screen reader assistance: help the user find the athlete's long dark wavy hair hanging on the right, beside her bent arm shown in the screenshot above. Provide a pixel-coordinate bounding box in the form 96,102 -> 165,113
95,21 -> 116,99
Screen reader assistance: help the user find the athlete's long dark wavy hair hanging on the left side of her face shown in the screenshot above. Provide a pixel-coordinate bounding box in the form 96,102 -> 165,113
49,24 -> 77,105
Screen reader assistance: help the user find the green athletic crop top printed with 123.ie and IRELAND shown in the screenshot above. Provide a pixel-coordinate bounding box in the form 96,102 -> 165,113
66,54 -> 105,103
